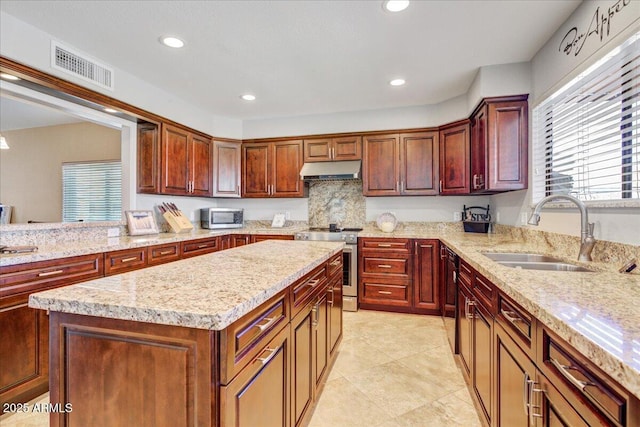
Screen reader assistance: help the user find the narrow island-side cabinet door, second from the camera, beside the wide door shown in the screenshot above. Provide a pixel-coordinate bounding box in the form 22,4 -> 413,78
291,303 -> 315,426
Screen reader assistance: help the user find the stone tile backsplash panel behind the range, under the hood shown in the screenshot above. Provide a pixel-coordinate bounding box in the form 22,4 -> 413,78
309,180 -> 366,227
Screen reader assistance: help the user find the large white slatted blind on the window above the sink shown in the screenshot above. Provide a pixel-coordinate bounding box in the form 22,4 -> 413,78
533,33 -> 640,202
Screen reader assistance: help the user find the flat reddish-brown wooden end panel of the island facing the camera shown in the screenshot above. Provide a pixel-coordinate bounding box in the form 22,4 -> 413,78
49,312 -> 218,427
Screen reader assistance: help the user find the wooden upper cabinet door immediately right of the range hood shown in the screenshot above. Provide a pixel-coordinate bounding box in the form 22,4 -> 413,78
362,134 -> 400,196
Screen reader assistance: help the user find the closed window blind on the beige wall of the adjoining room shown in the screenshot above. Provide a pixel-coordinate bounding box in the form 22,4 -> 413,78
62,160 -> 122,222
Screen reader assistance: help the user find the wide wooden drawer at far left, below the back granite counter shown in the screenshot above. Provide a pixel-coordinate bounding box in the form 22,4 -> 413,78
0,253 -> 104,298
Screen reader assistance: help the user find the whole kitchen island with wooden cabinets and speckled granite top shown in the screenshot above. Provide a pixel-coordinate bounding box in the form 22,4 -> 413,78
29,241 -> 343,426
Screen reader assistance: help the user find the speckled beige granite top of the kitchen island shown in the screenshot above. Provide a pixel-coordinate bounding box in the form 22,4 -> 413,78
29,240 -> 344,330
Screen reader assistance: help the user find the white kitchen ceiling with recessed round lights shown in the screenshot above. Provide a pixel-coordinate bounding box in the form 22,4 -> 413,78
0,0 -> 580,119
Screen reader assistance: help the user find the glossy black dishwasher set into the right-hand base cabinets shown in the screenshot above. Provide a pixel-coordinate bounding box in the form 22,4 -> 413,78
440,245 -> 460,354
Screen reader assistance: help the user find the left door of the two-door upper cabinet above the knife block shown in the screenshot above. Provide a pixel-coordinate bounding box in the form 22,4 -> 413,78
160,124 -> 190,195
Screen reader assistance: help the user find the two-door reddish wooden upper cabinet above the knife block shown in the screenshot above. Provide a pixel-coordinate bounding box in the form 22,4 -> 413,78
160,124 -> 213,196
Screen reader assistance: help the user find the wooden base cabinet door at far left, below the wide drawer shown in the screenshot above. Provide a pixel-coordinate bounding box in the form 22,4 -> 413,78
0,295 -> 49,415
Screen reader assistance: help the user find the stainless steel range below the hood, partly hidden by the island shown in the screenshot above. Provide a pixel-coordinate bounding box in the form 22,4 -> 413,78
295,228 -> 362,311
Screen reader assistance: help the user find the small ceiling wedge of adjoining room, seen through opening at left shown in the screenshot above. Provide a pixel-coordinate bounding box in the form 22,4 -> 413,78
0,96 -> 83,132
